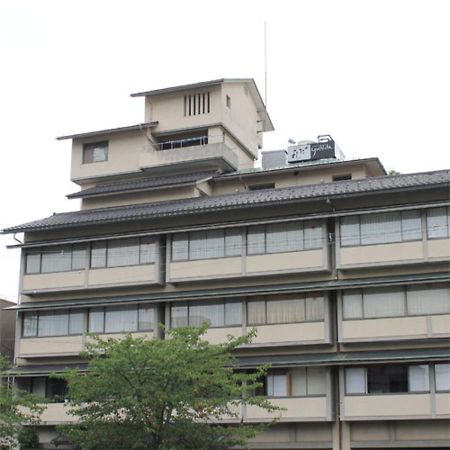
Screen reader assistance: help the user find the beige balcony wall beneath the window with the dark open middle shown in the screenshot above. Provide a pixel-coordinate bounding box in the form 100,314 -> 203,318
342,393 -> 450,420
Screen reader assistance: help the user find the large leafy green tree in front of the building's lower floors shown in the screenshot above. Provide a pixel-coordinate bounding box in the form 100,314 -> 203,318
60,326 -> 278,450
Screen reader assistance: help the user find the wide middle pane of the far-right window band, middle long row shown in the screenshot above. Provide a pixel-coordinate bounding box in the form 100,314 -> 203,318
363,287 -> 405,318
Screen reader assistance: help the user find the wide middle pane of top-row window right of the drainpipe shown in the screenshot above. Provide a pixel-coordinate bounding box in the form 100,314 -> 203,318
360,212 -> 402,245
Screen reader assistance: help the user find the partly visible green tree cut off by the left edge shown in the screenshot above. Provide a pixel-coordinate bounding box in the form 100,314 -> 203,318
0,355 -> 44,450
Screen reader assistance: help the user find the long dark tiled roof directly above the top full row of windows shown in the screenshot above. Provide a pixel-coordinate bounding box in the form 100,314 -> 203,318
3,169 -> 450,233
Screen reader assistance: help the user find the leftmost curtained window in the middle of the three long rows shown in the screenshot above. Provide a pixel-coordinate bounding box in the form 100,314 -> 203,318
22,310 -> 85,337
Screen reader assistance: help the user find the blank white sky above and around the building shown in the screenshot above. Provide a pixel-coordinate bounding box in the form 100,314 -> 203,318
0,0 -> 450,300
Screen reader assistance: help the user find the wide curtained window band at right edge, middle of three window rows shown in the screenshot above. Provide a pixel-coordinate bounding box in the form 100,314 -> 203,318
343,283 -> 450,320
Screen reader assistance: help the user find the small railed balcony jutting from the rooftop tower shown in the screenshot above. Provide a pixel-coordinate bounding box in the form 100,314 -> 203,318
139,135 -> 238,174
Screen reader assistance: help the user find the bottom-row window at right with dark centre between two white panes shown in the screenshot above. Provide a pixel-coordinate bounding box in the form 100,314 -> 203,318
345,364 -> 430,394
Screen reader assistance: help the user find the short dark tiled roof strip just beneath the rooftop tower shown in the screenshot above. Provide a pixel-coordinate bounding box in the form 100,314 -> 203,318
67,171 -> 217,198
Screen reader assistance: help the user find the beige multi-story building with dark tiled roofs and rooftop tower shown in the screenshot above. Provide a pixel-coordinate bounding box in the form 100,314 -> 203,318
0,79 -> 450,449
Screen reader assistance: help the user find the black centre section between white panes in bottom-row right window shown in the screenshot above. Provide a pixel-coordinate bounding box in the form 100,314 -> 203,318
366,366 -> 408,394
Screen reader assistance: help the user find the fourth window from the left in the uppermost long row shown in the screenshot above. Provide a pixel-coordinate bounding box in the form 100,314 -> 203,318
247,220 -> 323,255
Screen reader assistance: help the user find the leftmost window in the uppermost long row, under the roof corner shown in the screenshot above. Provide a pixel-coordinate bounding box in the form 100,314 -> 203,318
25,244 -> 86,274
